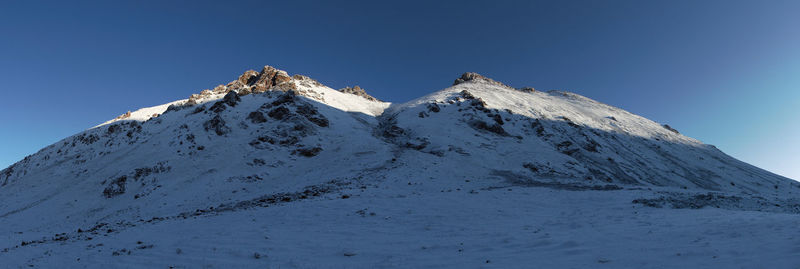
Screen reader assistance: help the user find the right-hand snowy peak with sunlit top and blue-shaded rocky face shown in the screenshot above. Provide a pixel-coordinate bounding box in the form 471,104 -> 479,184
384,80 -> 798,196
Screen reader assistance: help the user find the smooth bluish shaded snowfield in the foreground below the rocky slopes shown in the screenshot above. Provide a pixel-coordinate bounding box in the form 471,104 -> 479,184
0,179 -> 800,268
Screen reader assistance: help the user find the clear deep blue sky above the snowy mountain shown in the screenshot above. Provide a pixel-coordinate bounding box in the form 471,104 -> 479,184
0,0 -> 800,179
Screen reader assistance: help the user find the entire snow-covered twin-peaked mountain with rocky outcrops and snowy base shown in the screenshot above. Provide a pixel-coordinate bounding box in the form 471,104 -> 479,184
0,66 -> 800,267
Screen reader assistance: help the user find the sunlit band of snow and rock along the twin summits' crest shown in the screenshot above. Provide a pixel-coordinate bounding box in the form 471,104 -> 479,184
0,66 -> 792,191
